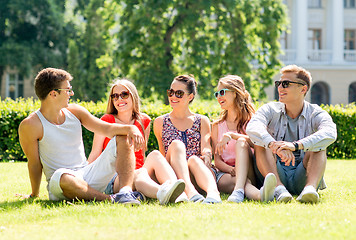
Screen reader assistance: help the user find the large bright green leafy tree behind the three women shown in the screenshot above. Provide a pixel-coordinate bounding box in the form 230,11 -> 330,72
106,0 -> 287,98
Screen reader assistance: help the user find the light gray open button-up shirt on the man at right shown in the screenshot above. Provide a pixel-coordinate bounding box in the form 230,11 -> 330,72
246,101 -> 337,157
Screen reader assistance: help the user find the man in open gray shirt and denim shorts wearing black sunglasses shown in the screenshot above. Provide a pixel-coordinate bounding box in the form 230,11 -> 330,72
246,65 -> 337,203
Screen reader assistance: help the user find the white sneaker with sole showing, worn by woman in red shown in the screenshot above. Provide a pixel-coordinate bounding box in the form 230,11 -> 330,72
157,179 -> 185,205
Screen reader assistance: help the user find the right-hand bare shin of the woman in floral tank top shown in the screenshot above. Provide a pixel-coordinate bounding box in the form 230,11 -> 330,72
188,156 -> 220,196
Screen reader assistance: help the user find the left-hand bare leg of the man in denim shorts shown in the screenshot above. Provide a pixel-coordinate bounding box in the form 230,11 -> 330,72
255,145 -> 283,186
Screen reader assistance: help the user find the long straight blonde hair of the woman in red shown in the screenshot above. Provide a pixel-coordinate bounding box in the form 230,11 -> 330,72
106,78 -> 141,120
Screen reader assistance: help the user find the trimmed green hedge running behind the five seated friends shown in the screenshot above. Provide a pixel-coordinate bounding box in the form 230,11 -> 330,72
0,98 -> 356,161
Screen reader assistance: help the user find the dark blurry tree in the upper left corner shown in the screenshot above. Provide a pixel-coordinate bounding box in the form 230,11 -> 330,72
0,0 -> 67,76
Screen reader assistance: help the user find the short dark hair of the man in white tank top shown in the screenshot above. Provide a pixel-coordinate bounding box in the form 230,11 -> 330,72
35,68 -> 73,100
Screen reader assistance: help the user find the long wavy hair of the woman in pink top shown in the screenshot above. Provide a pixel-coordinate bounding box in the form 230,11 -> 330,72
217,75 -> 256,134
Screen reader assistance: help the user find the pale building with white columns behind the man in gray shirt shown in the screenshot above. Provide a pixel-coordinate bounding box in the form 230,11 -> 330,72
266,0 -> 356,104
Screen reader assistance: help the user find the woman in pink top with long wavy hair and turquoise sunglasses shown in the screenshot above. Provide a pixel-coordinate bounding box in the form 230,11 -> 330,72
212,75 -> 276,203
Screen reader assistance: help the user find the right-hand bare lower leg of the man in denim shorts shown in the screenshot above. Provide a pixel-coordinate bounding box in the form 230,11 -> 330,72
303,150 -> 327,189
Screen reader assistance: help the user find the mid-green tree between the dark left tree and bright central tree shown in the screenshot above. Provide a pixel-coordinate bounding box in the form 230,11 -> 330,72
67,0 -> 112,101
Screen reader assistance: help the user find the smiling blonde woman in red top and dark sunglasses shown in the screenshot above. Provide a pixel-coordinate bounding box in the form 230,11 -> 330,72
88,79 -> 185,204
